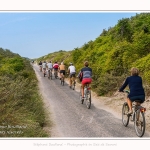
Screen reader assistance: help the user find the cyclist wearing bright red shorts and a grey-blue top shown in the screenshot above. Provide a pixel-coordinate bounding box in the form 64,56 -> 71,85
77,61 -> 92,100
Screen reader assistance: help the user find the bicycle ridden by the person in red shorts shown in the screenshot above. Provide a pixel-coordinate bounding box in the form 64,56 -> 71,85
80,84 -> 91,109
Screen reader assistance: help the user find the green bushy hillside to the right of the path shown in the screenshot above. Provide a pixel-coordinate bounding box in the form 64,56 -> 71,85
37,13 -> 150,96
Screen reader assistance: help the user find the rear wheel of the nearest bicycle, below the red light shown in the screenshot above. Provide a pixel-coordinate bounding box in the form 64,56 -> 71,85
134,109 -> 146,137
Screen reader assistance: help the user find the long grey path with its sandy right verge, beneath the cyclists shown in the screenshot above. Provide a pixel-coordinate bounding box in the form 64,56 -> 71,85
35,63 -> 150,137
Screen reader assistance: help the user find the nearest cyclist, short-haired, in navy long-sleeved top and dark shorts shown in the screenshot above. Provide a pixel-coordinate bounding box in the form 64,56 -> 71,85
119,67 -> 145,114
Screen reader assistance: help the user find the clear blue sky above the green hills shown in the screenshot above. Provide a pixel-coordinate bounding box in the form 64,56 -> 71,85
0,12 -> 136,58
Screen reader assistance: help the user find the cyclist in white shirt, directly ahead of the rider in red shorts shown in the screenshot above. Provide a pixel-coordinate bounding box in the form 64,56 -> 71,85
68,63 -> 76,88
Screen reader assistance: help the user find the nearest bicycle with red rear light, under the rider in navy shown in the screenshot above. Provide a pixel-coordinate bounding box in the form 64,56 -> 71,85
122,91 -> 146,137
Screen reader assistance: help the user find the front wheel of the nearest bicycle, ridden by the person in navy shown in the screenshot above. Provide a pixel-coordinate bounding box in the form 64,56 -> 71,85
122,102 -> 129,127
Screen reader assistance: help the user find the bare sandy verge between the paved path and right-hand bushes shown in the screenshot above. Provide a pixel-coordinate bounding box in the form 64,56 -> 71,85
66,79 -> 150,132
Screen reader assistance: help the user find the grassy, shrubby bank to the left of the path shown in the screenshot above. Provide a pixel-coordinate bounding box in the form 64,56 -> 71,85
0,48 -> 48,137
